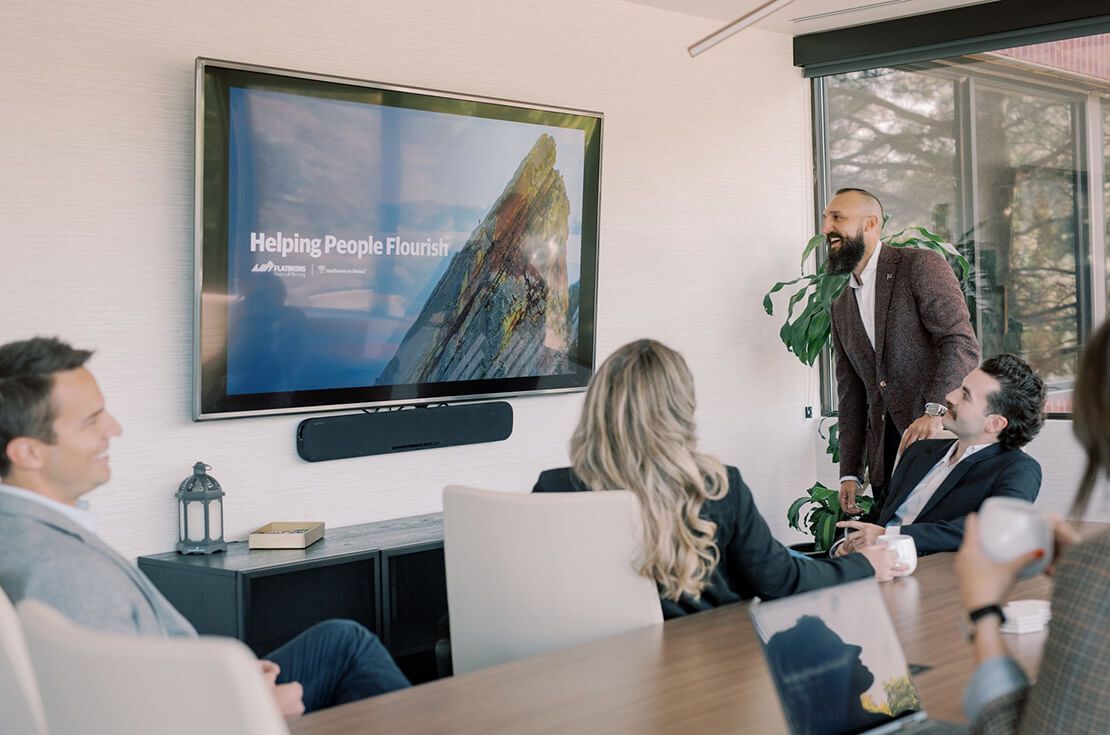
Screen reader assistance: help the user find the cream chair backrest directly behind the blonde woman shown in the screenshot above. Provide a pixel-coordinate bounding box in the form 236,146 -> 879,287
443,485 -> 663,674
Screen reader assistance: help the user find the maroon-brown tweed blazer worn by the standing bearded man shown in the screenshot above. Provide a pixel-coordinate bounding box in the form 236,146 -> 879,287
829,244 -> 979,484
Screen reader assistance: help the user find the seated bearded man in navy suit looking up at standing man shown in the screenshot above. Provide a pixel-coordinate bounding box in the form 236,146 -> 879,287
834,354 -> 1045,555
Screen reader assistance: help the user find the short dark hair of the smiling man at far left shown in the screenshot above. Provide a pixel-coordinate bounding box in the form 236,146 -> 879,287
0,336 -> 92,477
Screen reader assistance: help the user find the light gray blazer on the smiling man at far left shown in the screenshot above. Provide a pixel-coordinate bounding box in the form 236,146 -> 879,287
0,493 -> 196,637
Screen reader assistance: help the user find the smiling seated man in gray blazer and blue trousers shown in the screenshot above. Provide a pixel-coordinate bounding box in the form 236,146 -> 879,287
0,338 -> 408,717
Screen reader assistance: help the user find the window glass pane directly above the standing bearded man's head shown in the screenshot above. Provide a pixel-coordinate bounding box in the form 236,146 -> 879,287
826,69 -> 959,240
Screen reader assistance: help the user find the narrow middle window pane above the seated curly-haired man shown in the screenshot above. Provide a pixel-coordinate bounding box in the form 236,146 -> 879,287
975,84 -> 1081,408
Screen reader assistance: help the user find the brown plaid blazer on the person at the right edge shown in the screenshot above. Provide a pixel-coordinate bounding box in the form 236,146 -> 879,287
973,531 -> 1110,735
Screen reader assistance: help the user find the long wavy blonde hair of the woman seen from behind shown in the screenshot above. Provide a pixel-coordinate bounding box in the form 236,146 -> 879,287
571,340 -> 728,600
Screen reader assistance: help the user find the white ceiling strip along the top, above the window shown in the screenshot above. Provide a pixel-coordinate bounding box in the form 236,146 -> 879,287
626,0 -> 996,36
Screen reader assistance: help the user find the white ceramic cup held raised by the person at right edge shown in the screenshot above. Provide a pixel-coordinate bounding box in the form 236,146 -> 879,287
979,497 -> 1053,578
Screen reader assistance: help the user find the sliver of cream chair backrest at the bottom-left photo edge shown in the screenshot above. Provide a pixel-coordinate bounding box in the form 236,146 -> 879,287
0,590 -> 47,735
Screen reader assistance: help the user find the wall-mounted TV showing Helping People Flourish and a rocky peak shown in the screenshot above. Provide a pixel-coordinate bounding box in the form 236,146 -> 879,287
193,59 -> 602,420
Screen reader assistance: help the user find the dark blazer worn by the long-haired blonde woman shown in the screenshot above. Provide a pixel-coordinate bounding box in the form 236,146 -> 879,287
532,466 -> 875,620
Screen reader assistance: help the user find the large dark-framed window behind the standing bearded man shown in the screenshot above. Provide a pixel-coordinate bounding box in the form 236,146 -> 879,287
814,34 -> 1110,414
